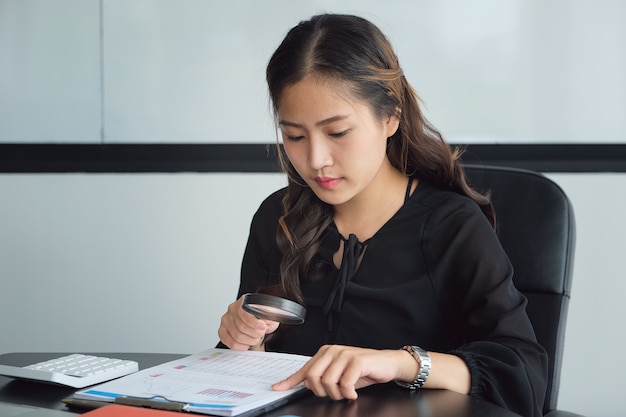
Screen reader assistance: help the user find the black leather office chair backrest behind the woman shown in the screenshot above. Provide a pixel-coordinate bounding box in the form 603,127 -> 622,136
465,165 -> 575,413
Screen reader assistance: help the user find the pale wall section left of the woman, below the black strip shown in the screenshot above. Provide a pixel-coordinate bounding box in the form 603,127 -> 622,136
0,174 -> 284,352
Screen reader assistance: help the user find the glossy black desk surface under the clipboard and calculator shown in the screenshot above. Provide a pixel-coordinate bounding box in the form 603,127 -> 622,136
0,353 -> 519,417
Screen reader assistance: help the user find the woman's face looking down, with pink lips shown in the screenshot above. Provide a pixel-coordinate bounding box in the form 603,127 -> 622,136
278,77 -> 398,206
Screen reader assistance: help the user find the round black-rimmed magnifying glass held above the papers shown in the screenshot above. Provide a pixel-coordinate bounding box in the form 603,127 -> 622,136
242,293 -> 306,324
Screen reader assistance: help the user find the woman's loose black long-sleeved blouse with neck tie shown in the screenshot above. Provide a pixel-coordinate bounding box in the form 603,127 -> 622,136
239,180 -> 547,416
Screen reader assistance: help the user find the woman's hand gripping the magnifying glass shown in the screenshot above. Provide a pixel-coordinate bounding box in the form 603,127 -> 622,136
217,296 -> 280,350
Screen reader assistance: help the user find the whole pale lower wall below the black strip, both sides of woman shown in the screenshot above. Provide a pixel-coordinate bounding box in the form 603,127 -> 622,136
0,174 -> 626,417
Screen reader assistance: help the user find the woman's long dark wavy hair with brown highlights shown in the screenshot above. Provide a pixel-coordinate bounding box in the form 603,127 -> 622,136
266,14 -> 495,301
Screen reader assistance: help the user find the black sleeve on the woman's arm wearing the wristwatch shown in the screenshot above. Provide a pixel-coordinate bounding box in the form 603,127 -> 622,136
424,197 -> 547,416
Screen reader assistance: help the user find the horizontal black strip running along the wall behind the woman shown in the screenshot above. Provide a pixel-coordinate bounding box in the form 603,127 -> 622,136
0,144 -> 626,173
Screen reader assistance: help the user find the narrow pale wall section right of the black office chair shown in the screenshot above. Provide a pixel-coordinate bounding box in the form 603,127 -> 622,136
548,173 -> 626,417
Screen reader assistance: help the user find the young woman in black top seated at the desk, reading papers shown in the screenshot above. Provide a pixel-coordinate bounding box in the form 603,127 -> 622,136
218,15 -> 547,416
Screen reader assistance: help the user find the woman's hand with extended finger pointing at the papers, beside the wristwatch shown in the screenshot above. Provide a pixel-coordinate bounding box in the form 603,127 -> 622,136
272,345 -> 418,400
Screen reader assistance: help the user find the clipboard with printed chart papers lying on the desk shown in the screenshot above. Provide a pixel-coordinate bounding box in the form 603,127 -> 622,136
74,348 -> 310,416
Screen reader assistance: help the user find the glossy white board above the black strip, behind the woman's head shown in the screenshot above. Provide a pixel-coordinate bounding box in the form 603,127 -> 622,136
0,0 -> 626,144
